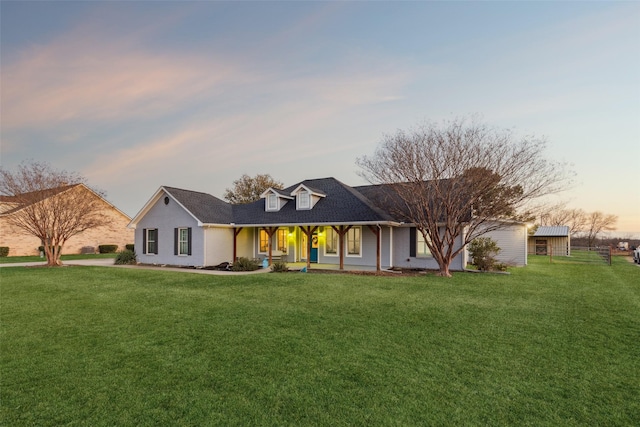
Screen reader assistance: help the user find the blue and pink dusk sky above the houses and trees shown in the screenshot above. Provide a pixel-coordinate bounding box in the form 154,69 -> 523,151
0,0 -> 640,238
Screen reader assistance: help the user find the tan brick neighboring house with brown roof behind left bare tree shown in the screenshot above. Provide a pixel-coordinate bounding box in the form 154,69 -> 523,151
0,184 -> 134,256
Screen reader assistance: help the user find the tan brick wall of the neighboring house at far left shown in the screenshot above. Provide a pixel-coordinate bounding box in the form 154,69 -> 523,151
0,192 -> 134,256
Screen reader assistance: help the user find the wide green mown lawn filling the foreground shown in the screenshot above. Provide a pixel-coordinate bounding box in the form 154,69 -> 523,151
0,257 -> 640,426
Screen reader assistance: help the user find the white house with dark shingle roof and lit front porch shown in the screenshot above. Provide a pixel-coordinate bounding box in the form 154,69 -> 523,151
129,178 -> 526,270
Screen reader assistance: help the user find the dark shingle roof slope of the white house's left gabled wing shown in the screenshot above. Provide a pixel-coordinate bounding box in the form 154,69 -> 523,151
162,186 -> 233,224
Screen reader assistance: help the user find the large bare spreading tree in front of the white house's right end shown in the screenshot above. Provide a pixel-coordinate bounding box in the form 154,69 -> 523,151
357,118 -> 569,276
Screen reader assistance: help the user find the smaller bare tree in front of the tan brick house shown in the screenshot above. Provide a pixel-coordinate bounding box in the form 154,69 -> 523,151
0,162 -> 110,266
